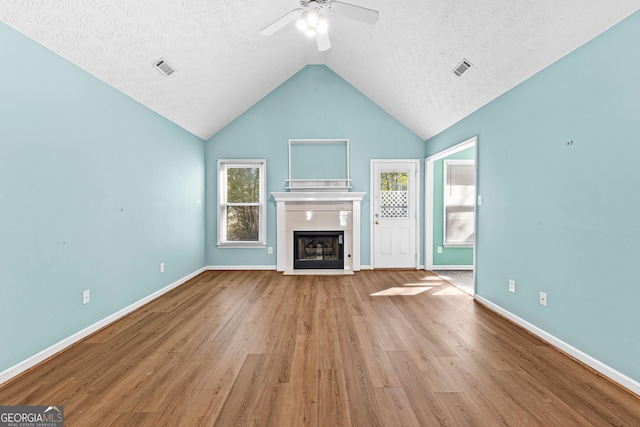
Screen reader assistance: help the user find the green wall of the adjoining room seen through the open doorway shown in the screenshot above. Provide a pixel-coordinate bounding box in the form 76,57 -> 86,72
433,147 -> 476,268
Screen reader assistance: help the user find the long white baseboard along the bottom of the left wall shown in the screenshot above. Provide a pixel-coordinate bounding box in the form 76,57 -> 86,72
0,268 -> 206,385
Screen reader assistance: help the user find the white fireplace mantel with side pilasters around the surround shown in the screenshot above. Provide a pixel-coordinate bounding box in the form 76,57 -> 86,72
271,191 -> 366,272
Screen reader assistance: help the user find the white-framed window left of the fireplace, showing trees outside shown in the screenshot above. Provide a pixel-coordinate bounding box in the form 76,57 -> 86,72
218,160 -> 267,248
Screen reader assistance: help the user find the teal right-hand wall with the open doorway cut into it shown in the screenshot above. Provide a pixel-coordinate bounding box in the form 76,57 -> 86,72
426,12 -> 640,381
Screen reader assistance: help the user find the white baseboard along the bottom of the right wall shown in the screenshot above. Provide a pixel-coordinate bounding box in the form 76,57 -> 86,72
475,295 -> 640,396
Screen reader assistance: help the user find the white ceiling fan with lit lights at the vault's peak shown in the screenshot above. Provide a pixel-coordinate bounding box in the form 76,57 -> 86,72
260,0 -> 379,52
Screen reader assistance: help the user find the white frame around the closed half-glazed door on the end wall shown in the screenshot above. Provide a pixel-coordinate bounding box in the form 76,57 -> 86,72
369,159 -> 422,270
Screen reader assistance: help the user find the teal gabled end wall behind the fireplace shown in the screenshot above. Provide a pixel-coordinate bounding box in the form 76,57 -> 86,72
206,65 -> 424,266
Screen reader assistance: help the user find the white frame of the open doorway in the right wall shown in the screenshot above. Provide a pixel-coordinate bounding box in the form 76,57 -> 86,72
424,136 -> 479,284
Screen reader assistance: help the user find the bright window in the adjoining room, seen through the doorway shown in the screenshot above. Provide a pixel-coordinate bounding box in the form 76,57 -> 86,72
444,160 -> 476,247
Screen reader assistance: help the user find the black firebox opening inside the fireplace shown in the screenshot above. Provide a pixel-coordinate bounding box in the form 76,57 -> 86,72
293,231 -> 344,270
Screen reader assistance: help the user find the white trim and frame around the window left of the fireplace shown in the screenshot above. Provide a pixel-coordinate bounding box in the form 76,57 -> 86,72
217,159 -> 267,248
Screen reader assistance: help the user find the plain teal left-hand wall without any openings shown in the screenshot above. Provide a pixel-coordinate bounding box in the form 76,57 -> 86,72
0,24 -> 204,372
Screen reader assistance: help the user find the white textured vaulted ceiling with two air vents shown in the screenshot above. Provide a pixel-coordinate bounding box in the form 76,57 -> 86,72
0,0 -> 640,139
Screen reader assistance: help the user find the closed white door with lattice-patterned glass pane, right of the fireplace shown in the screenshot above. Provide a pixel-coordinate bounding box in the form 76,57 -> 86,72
371,160 -> 420,268
